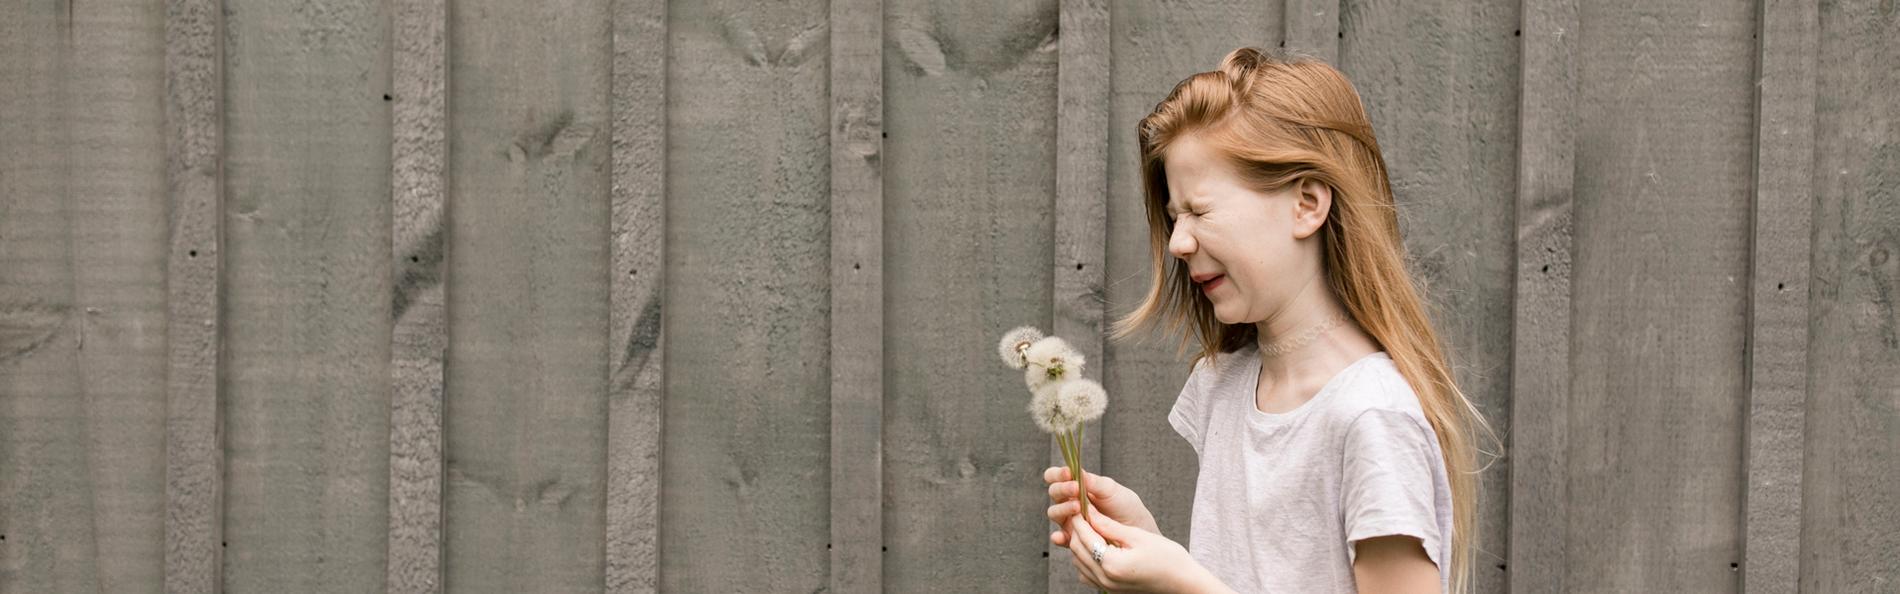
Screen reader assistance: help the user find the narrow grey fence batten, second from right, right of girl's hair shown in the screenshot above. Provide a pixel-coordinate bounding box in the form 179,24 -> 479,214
1503,0 -> 1581,594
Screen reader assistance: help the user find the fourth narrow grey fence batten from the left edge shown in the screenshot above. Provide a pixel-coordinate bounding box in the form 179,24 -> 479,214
828,0 -> 884,594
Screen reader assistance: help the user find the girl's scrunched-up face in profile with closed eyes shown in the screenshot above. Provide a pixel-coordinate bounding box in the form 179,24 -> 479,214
1163,135 -> 1332,325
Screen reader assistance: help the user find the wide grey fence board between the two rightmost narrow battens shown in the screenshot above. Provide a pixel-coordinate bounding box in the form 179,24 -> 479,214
1566,2 -> 1754,592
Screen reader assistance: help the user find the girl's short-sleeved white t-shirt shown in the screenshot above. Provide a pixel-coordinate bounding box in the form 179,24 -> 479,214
1169,345 -> 1452,592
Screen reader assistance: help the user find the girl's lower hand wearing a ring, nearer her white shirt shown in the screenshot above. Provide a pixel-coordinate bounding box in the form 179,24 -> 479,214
1068,514 -> 1210,592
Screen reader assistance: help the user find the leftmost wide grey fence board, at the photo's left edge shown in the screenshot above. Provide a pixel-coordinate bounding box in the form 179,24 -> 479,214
0,2 -> 167,592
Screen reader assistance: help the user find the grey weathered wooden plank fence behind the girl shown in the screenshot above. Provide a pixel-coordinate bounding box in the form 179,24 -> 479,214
0,0 -> 1900,592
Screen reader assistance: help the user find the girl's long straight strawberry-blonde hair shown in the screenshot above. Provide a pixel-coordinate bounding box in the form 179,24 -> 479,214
1112,47 -> 1497,592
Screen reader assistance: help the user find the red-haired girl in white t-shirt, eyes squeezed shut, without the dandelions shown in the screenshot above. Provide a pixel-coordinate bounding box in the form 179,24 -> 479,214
1043,47 -> 1495,592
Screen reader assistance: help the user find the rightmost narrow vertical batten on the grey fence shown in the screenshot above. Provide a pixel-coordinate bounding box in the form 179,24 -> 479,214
1739,0 -> 1820,594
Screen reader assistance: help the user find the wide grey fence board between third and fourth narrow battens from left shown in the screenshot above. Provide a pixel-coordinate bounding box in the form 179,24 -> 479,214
659,2 -> 828,592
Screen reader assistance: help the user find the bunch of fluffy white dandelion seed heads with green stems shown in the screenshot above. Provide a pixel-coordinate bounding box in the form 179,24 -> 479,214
996,326 -> 1108,520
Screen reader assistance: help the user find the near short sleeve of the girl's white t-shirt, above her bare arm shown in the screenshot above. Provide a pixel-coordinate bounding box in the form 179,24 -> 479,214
1340,408 -> 1448,571
